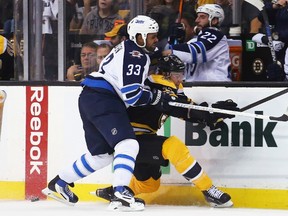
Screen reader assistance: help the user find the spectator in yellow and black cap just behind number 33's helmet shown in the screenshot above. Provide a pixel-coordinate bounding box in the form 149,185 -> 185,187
105,24 -> 129,46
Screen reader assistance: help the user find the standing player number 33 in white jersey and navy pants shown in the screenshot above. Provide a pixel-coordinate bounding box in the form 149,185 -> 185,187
42,15 -> 179,211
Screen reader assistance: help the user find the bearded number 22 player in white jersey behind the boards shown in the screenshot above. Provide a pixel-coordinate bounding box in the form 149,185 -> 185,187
163,4 -> 231,82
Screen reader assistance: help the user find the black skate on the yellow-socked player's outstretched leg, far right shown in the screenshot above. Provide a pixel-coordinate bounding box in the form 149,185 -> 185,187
202,185 -> 233,208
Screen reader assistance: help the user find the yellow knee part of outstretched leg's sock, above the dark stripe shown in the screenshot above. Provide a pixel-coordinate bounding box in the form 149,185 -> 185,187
162,136 -> 195,174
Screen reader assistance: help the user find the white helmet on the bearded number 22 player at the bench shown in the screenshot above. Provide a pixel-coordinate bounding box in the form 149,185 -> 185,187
196,4 -> 225,26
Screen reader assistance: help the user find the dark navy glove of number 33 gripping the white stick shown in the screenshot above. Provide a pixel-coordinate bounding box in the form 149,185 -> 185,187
150,89 -> 177,112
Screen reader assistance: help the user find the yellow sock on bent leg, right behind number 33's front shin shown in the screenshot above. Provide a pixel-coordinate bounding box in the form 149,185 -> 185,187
129,176 -> 160,195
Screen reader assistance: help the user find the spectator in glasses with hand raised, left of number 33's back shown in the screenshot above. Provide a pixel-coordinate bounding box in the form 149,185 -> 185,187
67,42 -> 98,81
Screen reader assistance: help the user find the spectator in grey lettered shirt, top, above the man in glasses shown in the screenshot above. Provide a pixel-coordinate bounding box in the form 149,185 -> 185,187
80,0 -> 122,40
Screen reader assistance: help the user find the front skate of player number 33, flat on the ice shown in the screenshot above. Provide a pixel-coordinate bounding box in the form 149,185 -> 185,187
107,186 -> 145,211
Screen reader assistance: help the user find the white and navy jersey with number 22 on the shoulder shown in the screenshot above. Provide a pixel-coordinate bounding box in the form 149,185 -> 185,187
171,27 -> 231,82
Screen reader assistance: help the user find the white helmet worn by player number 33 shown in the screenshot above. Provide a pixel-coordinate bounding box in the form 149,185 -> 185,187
127,15 -> 159,48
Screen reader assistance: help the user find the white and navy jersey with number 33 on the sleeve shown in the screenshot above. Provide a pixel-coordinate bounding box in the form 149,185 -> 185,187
81,40 -> 151,107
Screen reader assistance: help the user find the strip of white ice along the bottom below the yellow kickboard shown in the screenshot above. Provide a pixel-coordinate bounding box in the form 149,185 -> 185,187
0,200 -> 288,216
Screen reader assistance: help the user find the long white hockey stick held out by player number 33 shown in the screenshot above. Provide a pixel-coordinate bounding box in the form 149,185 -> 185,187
169,101 -> 288,122
